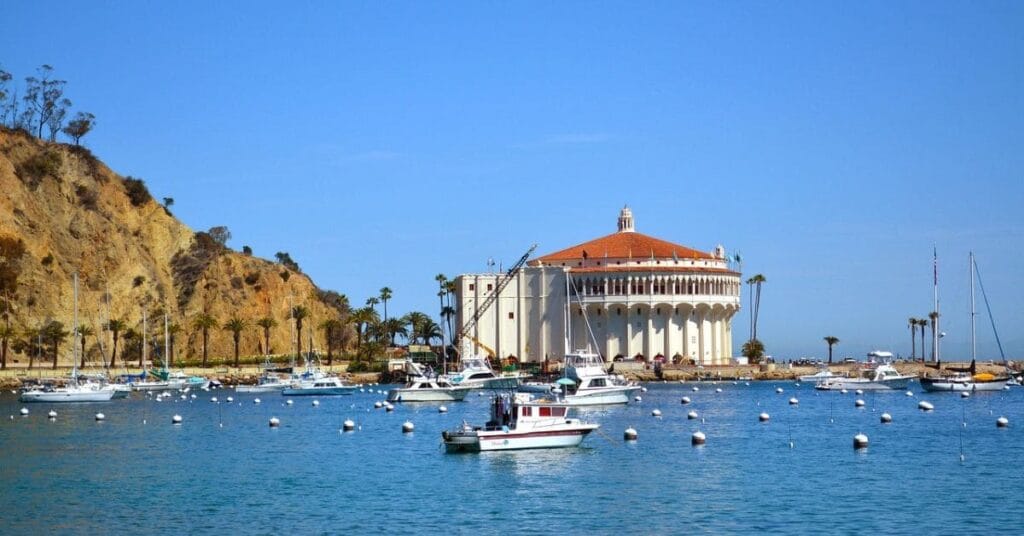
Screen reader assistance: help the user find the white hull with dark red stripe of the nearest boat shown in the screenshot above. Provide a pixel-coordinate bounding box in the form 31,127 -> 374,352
441,424 -> 598,453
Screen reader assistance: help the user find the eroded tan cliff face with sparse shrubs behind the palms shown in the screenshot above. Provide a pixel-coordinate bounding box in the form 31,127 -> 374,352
0,129 -> 344,362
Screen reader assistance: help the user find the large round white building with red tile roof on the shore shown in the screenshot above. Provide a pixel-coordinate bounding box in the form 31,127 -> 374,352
456,207 -> 742,365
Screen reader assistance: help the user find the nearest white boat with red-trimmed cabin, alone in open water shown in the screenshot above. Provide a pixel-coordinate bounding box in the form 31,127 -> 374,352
441,393 -> 600,452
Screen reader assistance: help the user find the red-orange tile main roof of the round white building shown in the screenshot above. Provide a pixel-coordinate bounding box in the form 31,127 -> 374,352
530,232 -> 715,265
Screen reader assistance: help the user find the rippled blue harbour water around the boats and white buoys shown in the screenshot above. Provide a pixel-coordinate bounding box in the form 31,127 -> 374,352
0,382 -> 1024,534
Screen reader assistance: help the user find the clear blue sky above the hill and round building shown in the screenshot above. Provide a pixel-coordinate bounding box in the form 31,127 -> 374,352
0,0 -> 1024,359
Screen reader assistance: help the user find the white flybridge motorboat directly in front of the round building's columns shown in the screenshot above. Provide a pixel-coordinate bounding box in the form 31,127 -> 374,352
557,349 -> 640,406
